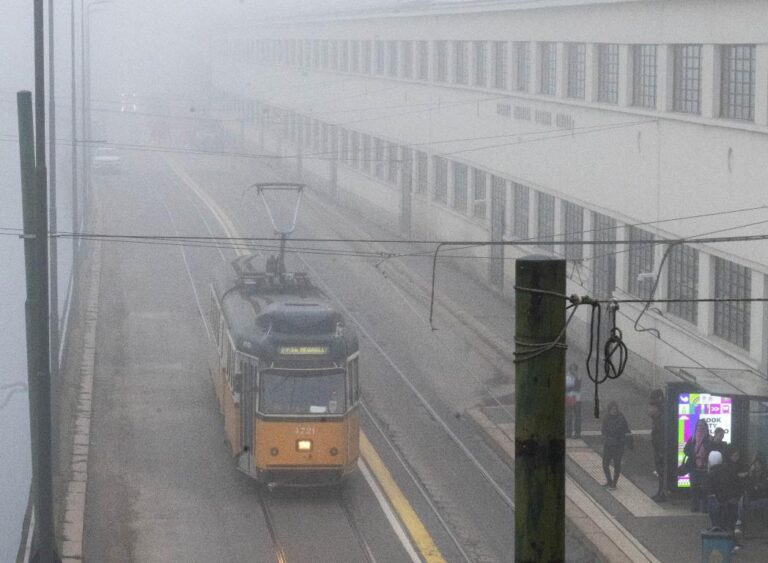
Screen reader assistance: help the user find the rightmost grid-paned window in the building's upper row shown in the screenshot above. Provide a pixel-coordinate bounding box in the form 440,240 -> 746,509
720,45 -> 755,121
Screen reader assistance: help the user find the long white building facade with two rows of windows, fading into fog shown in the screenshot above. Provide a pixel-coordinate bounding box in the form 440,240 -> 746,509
210,0 -> 768,394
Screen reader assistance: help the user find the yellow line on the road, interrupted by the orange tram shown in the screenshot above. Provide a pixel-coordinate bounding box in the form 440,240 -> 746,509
166,157 -> 445,563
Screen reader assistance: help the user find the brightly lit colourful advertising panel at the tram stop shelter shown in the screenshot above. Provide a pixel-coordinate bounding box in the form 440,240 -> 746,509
677,393 -> 733,488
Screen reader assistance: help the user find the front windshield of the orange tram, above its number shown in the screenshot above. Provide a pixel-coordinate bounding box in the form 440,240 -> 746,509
259,369 -> 346,414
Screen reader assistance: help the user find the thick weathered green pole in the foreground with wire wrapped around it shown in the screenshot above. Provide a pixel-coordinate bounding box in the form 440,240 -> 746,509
515,256 -> 565,563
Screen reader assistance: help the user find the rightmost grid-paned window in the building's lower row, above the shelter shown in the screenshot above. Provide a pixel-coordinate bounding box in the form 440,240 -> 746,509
713,257 -> 752,350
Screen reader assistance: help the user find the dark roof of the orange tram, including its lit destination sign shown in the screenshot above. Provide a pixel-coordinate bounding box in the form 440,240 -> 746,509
208,254 -> 358,359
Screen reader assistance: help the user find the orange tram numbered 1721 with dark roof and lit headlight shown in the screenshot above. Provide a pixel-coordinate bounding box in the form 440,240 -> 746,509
211,255 -> 360,488
